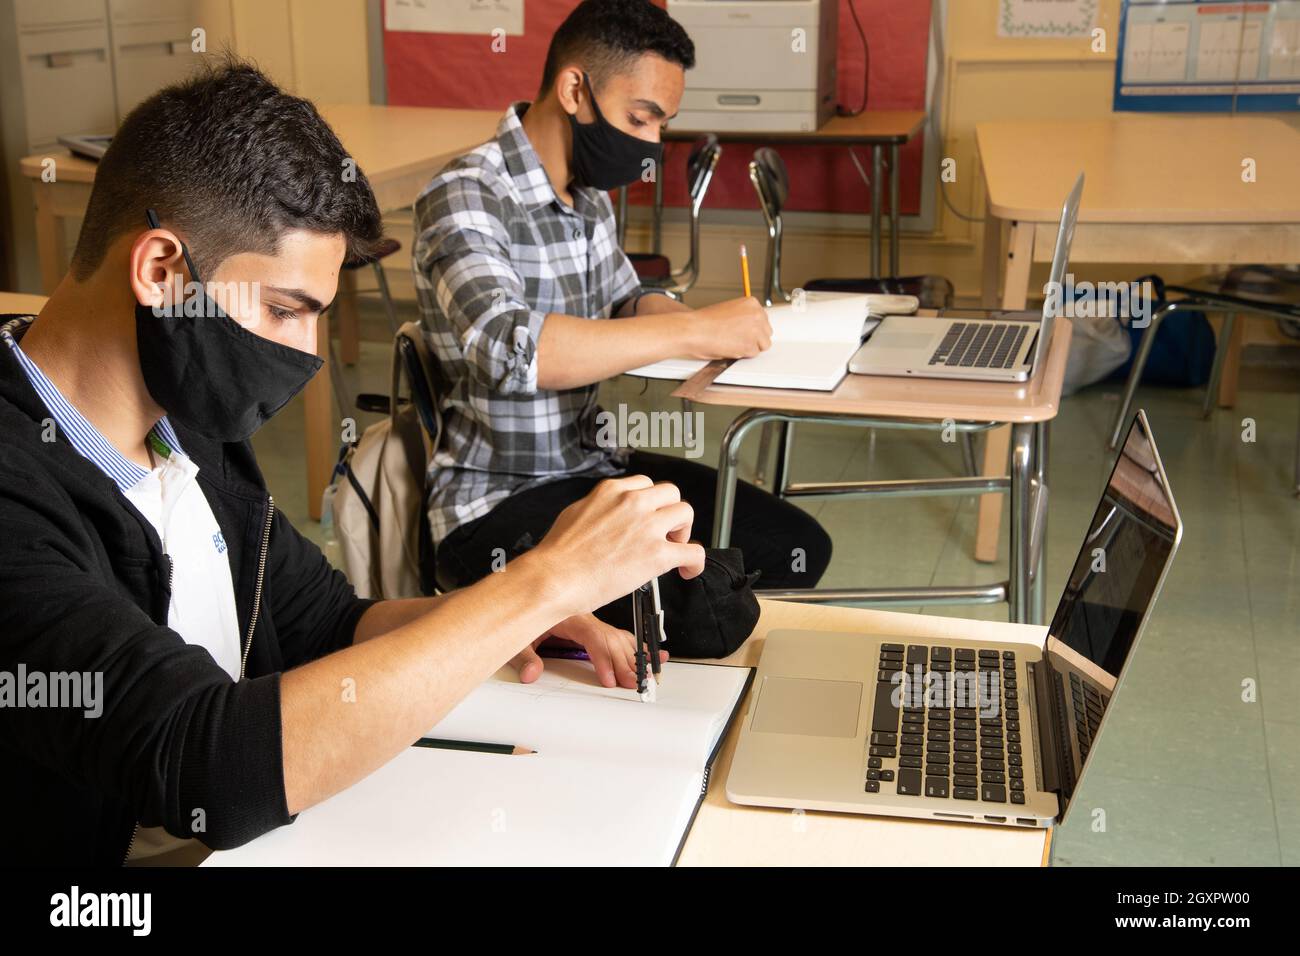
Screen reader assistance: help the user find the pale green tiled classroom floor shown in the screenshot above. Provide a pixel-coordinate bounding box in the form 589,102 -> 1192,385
255,312 -> 1300,865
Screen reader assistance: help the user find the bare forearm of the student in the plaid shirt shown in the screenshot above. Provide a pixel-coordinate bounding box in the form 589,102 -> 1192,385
537,312 -> 699,389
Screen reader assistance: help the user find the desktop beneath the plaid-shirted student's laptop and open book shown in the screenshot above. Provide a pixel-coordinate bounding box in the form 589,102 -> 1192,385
672,321 -> 1074,423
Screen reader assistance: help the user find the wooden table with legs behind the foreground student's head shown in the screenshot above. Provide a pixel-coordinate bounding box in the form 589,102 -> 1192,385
20,104 -> 504,519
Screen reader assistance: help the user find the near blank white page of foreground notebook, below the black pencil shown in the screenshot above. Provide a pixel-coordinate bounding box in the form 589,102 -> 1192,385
204,747 -> 702,866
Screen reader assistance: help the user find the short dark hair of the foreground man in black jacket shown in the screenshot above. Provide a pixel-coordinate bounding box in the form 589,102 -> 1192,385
72,56 -> 384,280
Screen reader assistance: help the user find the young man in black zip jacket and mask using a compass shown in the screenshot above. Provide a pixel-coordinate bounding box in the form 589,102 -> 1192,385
0,57 -> 703,865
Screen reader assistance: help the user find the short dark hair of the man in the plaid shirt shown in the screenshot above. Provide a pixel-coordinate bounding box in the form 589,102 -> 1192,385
540,0 -> 696,96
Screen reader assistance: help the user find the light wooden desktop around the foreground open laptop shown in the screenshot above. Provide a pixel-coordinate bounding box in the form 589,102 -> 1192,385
679,601 -> 1050,866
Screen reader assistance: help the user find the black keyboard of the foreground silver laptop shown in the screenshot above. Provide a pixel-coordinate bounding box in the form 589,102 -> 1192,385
866,644 -> 1024,804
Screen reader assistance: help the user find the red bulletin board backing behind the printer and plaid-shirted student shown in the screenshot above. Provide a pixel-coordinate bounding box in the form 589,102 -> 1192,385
384,0 -> 930,215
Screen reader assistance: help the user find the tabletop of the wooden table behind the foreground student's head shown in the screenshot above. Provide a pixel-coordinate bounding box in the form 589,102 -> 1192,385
20,103 -> 506,192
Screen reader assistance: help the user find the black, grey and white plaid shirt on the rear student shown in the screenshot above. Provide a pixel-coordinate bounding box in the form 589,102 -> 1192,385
412,103 -> 640,542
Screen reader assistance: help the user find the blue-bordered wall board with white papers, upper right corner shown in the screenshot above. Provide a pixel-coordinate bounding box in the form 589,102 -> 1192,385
1114,0 -> 1300,112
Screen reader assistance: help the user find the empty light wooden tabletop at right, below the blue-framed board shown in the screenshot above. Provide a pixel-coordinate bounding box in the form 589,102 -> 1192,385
975,116 -> 1300,224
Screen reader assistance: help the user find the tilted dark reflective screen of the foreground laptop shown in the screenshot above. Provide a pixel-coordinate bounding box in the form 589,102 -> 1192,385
1048,412 -> 1182,814
